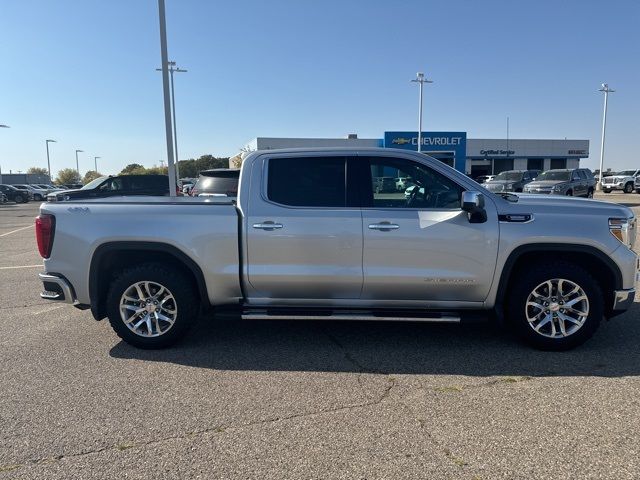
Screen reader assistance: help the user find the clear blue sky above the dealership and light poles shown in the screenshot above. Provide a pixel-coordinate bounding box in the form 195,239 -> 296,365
0,0 -> 640,173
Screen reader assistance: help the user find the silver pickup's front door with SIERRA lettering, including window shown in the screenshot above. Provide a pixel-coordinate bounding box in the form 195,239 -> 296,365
360,156 -> 498,302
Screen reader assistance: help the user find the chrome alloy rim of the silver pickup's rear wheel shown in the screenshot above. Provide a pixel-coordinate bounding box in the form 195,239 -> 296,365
120,281 -> 178,337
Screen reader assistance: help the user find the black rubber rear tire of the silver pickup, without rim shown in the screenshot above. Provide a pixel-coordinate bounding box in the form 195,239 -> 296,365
107,263 -> 200,349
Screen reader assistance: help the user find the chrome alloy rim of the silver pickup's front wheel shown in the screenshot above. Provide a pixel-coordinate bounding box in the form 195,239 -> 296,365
525,278 -> 589,338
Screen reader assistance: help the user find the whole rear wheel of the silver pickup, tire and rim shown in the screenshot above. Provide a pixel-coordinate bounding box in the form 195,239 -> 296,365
107,263 -> 199,349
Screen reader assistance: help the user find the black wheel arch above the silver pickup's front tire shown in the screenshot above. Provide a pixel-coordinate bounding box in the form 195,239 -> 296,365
496,243 -> 623,317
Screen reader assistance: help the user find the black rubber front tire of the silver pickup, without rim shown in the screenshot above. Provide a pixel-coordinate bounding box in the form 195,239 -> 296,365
506,262 -> 604,351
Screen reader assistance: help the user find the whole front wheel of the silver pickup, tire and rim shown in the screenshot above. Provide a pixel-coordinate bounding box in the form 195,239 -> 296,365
507,262 -> 604,350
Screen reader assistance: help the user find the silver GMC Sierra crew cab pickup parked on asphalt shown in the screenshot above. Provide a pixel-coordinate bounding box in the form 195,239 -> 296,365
36,149 -> 638,350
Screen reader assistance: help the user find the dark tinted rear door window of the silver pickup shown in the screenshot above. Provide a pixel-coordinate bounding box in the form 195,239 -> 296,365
267,157 -> 346,207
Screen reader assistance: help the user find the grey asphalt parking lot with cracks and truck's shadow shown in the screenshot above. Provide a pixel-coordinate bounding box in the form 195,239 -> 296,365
0,193 -> 640,479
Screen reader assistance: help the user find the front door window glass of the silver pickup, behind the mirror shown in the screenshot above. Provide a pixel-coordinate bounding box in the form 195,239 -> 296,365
368,157 -> 462,209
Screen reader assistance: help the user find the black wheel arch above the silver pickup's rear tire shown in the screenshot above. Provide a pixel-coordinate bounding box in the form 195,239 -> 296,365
89,241 -> 211,320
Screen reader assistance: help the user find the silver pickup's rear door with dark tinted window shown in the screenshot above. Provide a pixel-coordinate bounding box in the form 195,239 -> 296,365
241,153 -> 362,304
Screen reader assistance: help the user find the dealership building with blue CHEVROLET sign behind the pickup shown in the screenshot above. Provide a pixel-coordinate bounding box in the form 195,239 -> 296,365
243,131 -> 589,177
